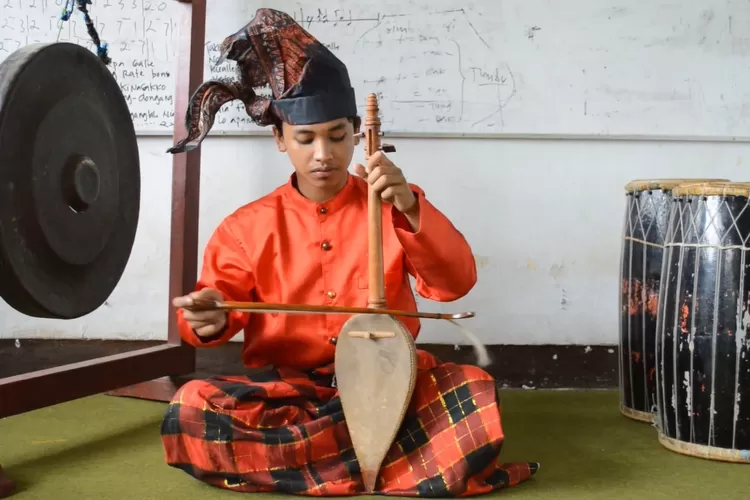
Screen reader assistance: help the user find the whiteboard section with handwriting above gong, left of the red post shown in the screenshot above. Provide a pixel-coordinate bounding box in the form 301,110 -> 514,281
0,0 -> 177,131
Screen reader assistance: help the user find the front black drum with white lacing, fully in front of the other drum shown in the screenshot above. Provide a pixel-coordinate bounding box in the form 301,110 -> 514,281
655,182 -> 750,463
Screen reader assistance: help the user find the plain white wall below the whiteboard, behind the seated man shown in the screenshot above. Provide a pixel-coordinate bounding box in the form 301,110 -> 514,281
0,137 -> 750,345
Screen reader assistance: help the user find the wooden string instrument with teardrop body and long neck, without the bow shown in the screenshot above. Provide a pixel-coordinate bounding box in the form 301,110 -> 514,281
335,94 -> 417,493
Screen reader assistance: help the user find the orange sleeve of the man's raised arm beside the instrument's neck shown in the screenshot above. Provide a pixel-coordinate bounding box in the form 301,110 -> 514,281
391,184 -> 477,302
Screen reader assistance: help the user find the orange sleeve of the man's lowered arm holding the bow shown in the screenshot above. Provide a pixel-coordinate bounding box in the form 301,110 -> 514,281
177,219 -> 255,347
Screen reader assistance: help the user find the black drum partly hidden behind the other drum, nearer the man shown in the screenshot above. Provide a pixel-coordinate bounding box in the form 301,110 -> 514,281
619,179 -> 725,422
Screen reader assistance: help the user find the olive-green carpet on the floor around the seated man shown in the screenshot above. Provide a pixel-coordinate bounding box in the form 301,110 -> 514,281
0,391 -> 750,500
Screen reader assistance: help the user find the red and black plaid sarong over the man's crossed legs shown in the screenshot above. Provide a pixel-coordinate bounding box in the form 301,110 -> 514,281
161,351 -> 538,497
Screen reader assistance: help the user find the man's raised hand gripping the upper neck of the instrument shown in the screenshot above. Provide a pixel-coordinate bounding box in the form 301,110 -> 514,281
354,151 -> 419,215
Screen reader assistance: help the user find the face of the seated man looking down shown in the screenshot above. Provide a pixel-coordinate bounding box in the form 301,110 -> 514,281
273,118 -> 359,191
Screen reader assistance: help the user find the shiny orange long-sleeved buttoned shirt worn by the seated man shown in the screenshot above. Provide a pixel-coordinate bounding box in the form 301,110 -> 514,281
177,175 -> 477,370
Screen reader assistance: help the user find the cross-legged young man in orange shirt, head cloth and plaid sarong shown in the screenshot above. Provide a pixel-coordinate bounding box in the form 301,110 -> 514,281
162,9 -> 537,496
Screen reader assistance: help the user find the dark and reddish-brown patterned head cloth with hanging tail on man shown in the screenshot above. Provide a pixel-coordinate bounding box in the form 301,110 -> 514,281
167,9 -> 357,154
